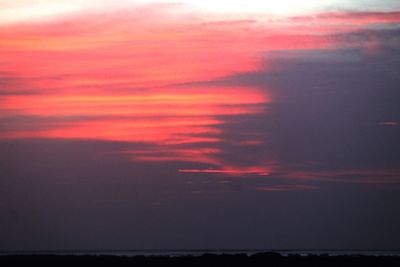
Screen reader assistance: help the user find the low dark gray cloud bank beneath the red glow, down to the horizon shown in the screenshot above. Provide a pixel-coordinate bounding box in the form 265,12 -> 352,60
0,140 -> 400,249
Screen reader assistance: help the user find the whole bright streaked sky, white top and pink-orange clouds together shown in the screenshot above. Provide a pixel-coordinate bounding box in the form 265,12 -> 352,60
0,1 -> 400,183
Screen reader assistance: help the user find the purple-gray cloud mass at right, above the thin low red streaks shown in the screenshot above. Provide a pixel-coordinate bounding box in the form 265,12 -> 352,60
209,42 -> 400,176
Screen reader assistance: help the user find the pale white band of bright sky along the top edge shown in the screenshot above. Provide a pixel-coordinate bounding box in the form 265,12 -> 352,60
0,0 -> 400,24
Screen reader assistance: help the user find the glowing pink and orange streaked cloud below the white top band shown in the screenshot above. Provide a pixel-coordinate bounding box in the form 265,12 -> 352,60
0,6 -> 398,176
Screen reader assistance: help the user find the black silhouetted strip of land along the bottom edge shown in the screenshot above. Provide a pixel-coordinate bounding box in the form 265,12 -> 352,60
0,253 -> 400,267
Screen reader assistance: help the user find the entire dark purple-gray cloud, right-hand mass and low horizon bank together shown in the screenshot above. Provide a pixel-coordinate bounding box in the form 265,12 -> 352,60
0,26 -> 400,249
